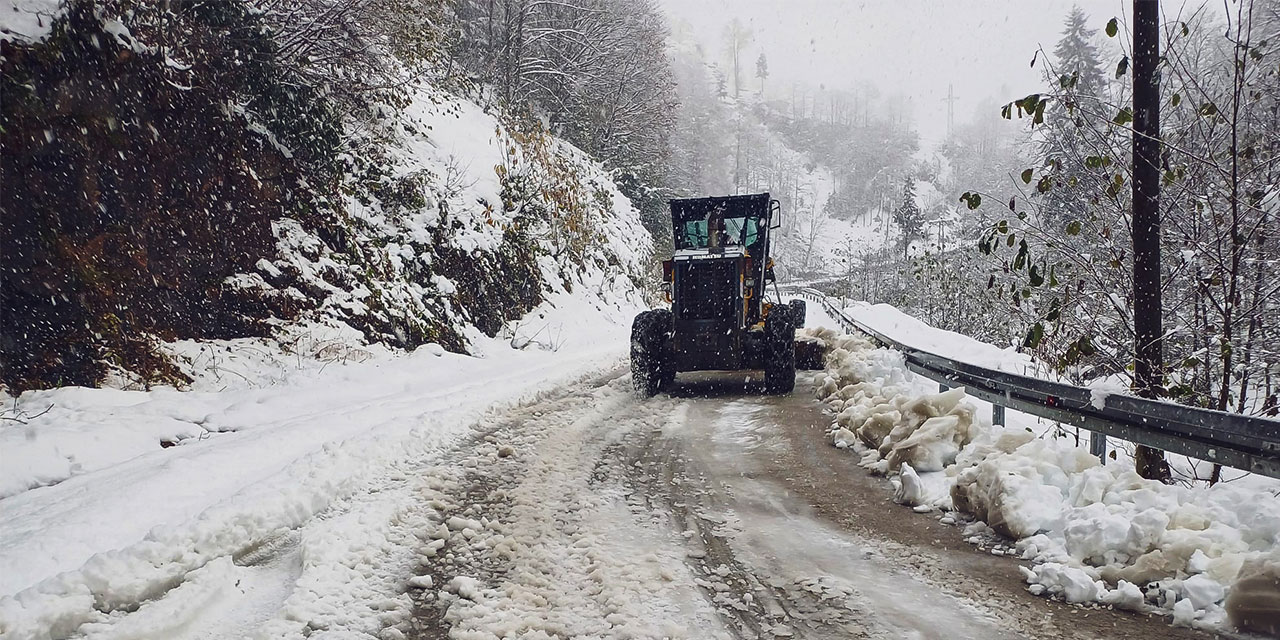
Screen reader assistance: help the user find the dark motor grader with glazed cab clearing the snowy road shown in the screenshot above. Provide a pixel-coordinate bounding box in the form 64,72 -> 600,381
631,193 -> 805,397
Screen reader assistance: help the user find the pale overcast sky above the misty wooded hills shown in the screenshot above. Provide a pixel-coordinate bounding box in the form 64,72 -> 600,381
659,0 -> 1136,140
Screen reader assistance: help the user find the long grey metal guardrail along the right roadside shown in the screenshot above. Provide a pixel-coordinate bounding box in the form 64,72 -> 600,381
792,288 -> 1280,477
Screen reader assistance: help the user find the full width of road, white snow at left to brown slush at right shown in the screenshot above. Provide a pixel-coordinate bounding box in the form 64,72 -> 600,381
0,302 -> 1223,640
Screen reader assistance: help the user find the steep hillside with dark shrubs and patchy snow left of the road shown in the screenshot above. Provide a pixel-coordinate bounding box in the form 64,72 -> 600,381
0,1 -> 652,390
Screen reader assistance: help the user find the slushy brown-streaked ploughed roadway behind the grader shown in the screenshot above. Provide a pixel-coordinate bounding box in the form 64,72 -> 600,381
407,370 -> 1210,639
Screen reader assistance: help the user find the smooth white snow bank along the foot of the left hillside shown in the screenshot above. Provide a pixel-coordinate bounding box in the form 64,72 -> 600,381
0,298 -> 637,639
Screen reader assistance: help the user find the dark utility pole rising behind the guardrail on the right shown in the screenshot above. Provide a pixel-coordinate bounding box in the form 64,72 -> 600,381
1132,0 -> 1170,483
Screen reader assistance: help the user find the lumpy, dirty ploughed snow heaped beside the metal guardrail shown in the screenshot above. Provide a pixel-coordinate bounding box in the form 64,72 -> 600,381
817,335 -> 1280,630
